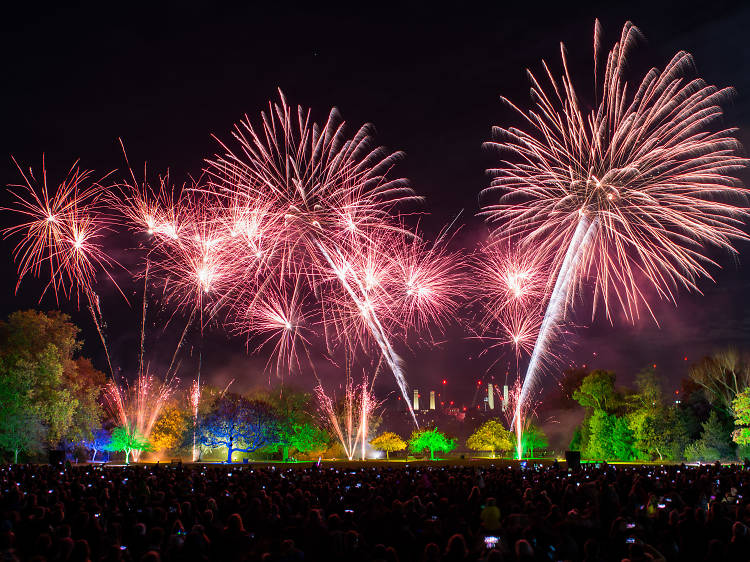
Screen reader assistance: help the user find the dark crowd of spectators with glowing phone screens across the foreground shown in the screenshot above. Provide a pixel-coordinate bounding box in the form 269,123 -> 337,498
0,464 -> 750,562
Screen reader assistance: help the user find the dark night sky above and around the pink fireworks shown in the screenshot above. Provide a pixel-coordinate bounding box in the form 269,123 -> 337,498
0,1 -> 750,402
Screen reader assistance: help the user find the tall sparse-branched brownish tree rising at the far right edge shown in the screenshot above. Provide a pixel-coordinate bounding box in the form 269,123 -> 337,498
689,348 -> 750,417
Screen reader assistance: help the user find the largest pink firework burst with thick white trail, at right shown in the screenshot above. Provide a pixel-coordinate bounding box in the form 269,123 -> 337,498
482,21 -> 747,451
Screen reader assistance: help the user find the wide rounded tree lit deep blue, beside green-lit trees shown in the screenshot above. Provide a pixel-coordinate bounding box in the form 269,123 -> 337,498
198,393 -> 276,463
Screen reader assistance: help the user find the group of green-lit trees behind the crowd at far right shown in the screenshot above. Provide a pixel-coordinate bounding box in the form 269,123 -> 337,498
561,349 -> 750,462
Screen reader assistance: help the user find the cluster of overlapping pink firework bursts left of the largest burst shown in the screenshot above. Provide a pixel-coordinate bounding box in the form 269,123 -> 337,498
6,95 -> 462,434
